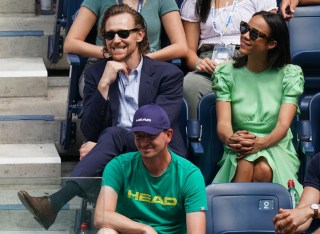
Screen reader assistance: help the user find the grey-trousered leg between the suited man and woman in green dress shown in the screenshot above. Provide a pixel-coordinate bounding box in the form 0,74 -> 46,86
183,72 -> 212,119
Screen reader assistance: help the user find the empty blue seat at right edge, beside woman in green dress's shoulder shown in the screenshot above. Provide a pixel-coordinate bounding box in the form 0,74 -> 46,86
288,5 -> 320,119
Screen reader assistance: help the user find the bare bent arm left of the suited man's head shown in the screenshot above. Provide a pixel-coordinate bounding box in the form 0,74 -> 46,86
63,7 -> 103,58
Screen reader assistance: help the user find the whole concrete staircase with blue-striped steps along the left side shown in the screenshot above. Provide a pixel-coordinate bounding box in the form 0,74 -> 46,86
0,0 -> 87,234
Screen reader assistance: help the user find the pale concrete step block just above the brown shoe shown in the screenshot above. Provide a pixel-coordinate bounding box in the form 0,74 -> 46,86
0,143 -> 61,180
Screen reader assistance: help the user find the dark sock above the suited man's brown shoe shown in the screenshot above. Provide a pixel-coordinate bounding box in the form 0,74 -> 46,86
49,181 -> 83,213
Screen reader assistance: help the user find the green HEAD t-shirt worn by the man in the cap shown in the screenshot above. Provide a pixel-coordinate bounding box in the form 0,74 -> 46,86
102,151 -> 207,234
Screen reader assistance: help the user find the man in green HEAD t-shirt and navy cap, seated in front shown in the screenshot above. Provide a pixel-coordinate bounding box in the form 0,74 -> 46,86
94,104 -> 207,234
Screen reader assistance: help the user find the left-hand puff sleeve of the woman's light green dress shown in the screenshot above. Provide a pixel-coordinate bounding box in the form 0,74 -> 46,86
212,62 -> 234,102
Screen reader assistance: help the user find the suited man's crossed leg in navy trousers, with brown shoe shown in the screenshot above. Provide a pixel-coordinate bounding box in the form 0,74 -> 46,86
18,127 -> 137,229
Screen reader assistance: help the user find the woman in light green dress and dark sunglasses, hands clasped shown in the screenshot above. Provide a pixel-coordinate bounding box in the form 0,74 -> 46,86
213,11 -> 304,194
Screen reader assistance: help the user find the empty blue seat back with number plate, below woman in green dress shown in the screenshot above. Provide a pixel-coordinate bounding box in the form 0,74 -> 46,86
206,183 -> 292,234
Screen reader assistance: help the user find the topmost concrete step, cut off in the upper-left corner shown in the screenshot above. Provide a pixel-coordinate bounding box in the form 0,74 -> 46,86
0,0 -> 35,14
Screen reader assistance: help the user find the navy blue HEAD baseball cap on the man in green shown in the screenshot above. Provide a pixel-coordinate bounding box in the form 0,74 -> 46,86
130,104 -> 170,135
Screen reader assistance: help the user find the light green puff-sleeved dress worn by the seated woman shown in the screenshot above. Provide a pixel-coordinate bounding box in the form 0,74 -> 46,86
213,62 -> 304,195
